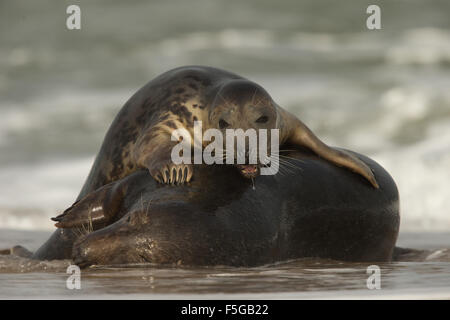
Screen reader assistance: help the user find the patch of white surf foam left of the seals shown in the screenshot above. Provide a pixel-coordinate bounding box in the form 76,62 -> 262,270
0,158 -> 93,230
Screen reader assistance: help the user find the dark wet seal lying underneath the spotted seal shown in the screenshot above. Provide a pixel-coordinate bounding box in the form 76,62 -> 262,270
49,149 -> 400,267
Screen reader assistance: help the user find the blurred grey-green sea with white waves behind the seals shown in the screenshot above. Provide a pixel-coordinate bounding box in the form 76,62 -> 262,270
0,0 -> 450,232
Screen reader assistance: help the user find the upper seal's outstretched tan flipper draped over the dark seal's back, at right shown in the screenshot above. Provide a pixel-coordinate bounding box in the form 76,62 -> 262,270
277,106 -> 379,189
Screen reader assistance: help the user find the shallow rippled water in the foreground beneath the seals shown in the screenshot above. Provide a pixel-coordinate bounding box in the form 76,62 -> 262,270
0,230 -> 450,299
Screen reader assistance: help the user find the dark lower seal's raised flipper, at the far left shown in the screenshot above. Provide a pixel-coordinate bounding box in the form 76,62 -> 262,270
52,182 -> 126,230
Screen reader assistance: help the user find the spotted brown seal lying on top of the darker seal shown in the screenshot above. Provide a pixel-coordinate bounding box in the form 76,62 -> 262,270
78,66 -> 378,199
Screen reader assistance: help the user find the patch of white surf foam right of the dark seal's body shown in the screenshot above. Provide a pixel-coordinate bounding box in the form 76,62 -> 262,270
373,121 -> 450,231
